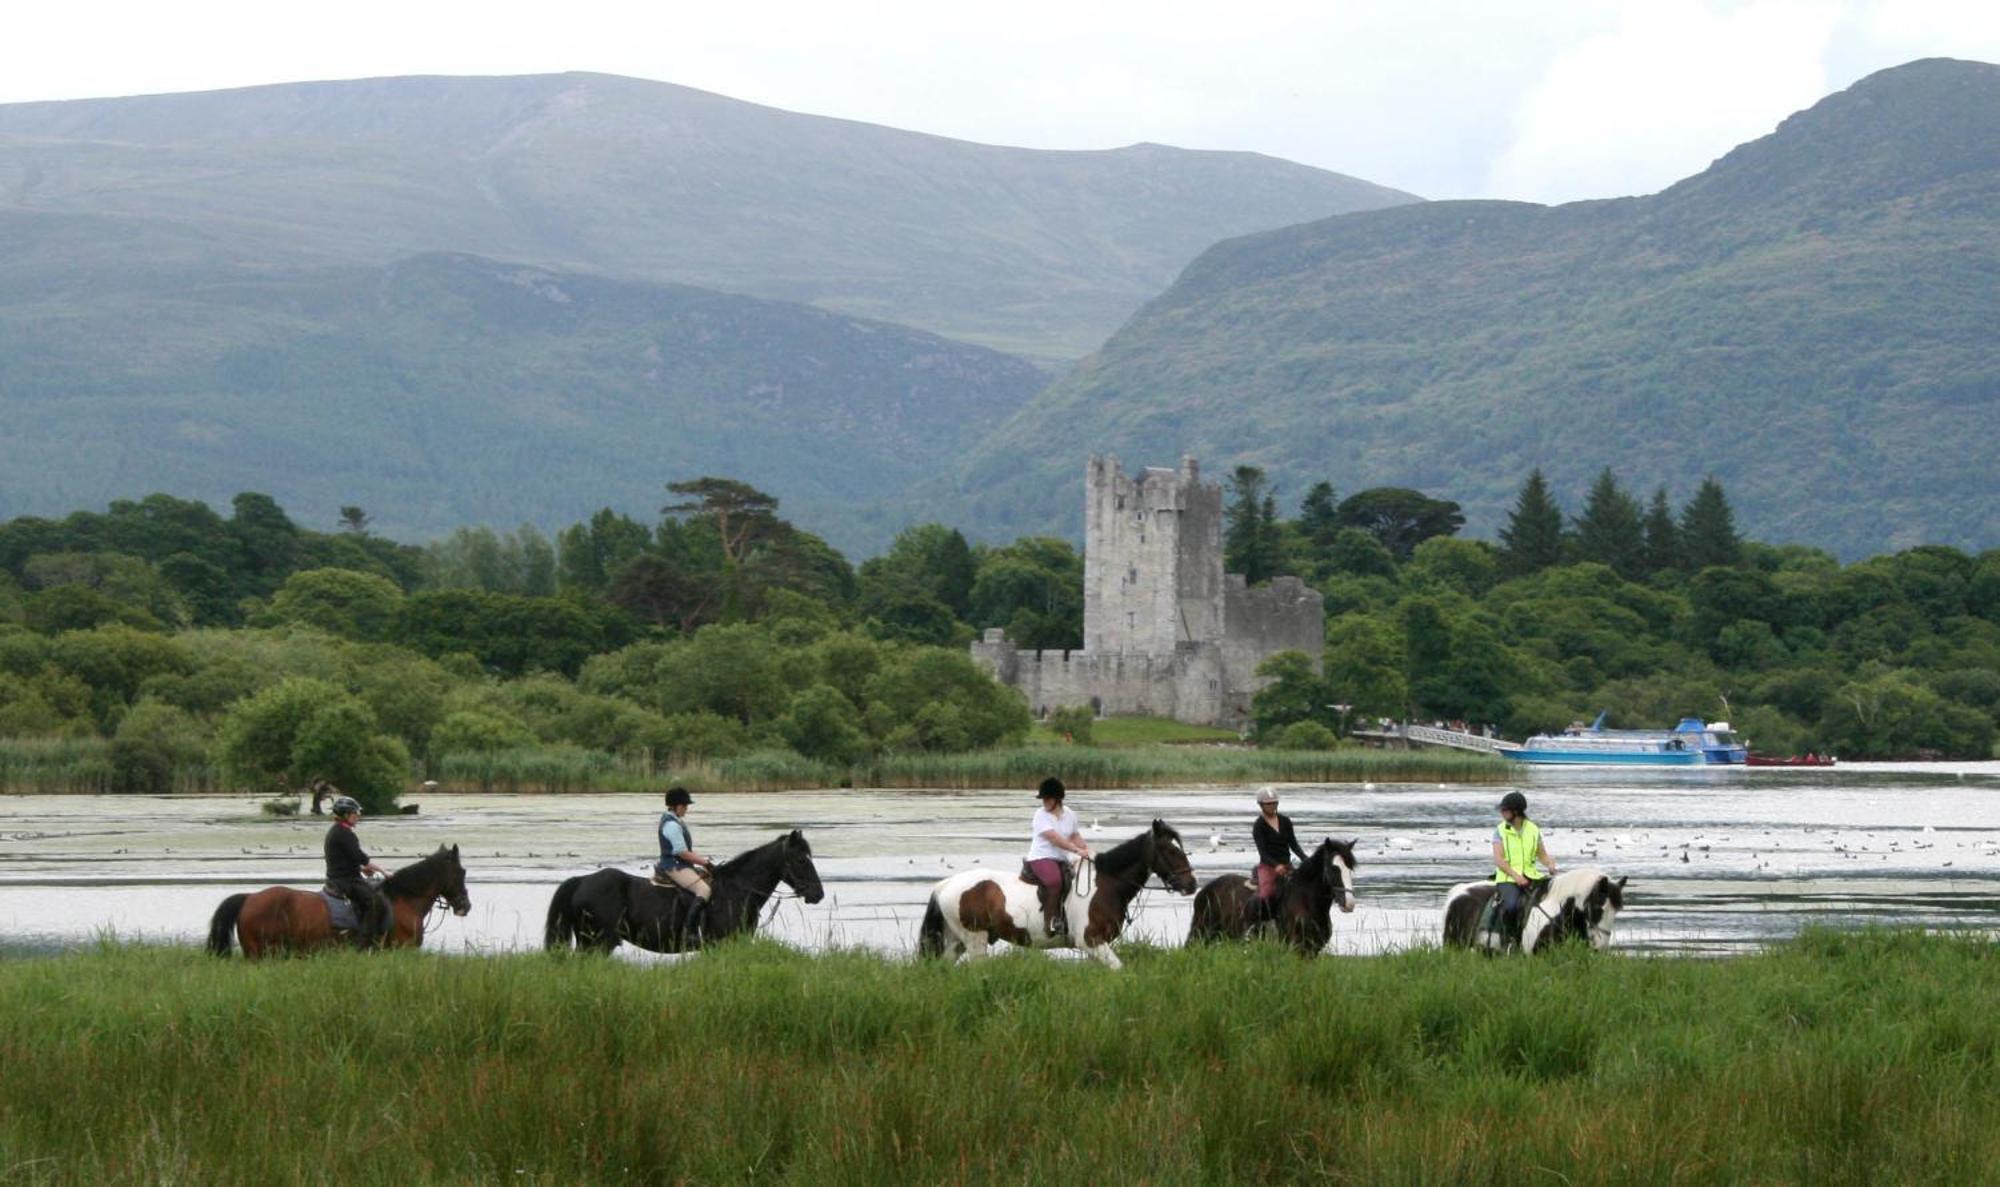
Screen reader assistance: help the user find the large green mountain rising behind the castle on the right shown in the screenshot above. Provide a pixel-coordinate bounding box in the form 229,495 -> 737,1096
948,60 -> 2000,556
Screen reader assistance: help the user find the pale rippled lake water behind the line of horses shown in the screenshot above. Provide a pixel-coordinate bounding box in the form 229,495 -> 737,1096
0,763 -> 2000,959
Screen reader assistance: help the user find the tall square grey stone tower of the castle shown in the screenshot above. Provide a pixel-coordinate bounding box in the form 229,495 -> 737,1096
1084,458 -> 1224,655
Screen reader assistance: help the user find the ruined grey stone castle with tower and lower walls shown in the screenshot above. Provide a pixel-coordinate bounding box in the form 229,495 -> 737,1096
972,458 -> 1326,727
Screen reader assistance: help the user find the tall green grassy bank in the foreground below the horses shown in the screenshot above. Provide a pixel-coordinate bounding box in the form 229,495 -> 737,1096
0,933 -> 2000,1185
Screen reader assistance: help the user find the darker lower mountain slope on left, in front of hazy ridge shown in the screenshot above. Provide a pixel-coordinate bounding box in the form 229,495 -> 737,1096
0,249 -> 1046,544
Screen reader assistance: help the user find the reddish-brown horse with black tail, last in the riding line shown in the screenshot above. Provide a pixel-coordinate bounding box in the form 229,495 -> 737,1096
208,845 -> 472,957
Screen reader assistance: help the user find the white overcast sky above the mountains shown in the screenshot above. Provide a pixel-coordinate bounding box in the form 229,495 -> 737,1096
0,0 -> 2000,202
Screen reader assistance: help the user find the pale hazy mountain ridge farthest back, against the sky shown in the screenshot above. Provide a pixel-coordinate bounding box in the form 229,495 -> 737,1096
0,74 -> 1414,362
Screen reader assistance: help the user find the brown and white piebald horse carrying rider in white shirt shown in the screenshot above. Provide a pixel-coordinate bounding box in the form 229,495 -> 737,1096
916,819 -> 1194,969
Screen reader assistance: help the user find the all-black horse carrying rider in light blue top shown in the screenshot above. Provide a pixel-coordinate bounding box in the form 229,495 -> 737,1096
542,829 -> 826,953
